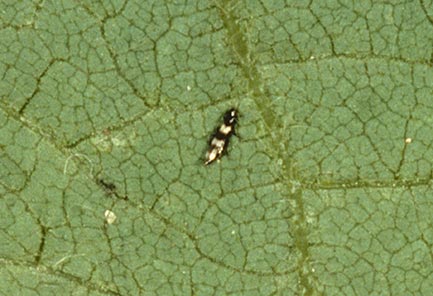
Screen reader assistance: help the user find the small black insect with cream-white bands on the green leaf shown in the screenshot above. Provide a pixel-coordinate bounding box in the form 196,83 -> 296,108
204,108 -> 238,165
